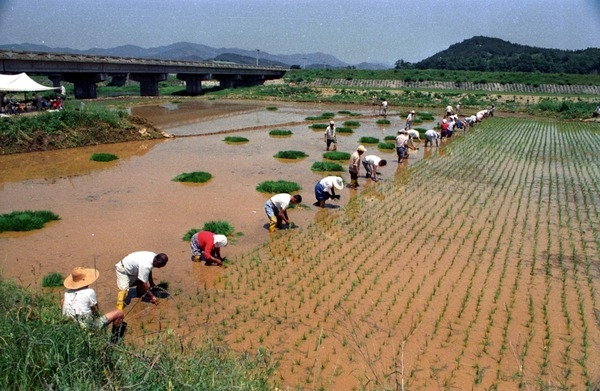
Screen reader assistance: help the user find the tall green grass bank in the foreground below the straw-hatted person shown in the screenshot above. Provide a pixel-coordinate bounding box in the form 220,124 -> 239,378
0,279 -> 276,391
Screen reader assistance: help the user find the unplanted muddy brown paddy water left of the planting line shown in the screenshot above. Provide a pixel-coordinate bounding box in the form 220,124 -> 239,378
0,101 -> 441,388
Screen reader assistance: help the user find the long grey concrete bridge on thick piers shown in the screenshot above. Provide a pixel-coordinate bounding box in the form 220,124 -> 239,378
0,50 -> 287,99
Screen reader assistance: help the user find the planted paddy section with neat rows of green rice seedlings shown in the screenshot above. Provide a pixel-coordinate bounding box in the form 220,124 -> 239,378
165,118 -> 600,389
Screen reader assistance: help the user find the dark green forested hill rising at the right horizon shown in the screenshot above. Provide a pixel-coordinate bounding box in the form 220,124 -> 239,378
396,37 -> 600,74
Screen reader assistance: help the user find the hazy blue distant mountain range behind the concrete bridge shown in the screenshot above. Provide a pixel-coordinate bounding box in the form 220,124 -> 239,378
0,42 -> 390,69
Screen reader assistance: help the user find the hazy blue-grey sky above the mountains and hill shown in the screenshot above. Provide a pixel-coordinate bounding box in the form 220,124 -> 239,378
0,0 -> 600,65
